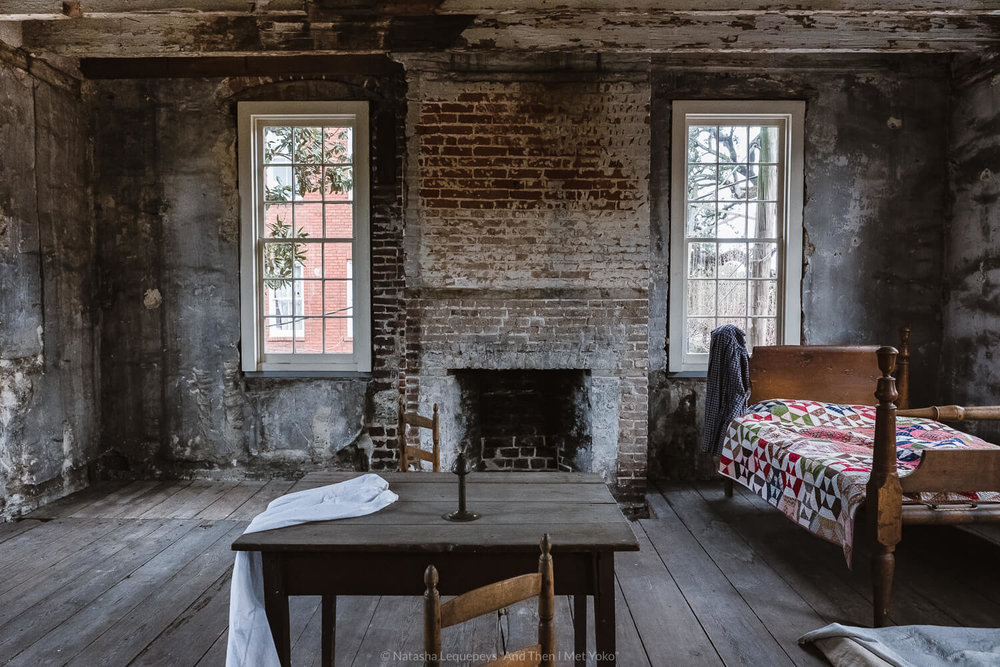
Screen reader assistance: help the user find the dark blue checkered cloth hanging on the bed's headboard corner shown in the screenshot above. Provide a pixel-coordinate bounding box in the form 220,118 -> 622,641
701,324 -> 750,454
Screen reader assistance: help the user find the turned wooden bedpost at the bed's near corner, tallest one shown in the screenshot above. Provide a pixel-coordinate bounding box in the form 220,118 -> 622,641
865,347 -> 903,628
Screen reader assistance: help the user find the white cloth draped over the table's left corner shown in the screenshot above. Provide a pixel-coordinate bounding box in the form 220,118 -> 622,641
226,474 -> 398,667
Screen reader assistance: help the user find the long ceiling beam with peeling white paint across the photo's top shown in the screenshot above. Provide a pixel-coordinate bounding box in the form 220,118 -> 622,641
13,10 -> 1000,57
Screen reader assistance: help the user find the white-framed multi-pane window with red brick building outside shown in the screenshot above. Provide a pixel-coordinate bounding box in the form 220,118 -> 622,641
238,102 -> 371,372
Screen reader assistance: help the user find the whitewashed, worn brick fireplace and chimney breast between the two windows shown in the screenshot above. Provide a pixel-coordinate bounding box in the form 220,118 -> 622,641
403,65 -> 649,503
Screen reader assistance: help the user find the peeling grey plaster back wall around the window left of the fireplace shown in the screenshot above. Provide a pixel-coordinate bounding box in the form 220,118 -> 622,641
94,77 -> 403,477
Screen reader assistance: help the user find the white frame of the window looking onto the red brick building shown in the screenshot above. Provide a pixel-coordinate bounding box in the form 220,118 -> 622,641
237,102 -> 371,373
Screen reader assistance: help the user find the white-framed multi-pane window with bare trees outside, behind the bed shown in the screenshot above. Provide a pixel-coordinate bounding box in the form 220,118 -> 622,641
670,101 -> 805,372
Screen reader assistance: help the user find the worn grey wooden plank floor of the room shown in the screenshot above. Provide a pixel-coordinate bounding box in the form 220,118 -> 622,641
0,481 -> 1000,667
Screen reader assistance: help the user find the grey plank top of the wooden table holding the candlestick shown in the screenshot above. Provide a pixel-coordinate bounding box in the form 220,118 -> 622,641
233,472 -> 639,553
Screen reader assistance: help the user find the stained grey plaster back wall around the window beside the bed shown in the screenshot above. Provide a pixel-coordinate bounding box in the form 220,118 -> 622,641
649,55 -> 948,478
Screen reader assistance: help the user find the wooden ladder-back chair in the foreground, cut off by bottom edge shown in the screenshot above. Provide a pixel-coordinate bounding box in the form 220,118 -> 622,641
424,533 -> 556,667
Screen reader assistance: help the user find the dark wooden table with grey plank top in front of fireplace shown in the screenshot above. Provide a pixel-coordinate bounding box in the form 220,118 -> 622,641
233,472 -> 639,665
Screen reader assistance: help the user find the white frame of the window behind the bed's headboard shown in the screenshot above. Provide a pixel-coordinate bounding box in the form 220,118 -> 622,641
669,100 -> 805,375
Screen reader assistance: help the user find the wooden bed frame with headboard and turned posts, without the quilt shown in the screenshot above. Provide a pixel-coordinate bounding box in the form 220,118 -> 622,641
726,329 -> 1000,627
